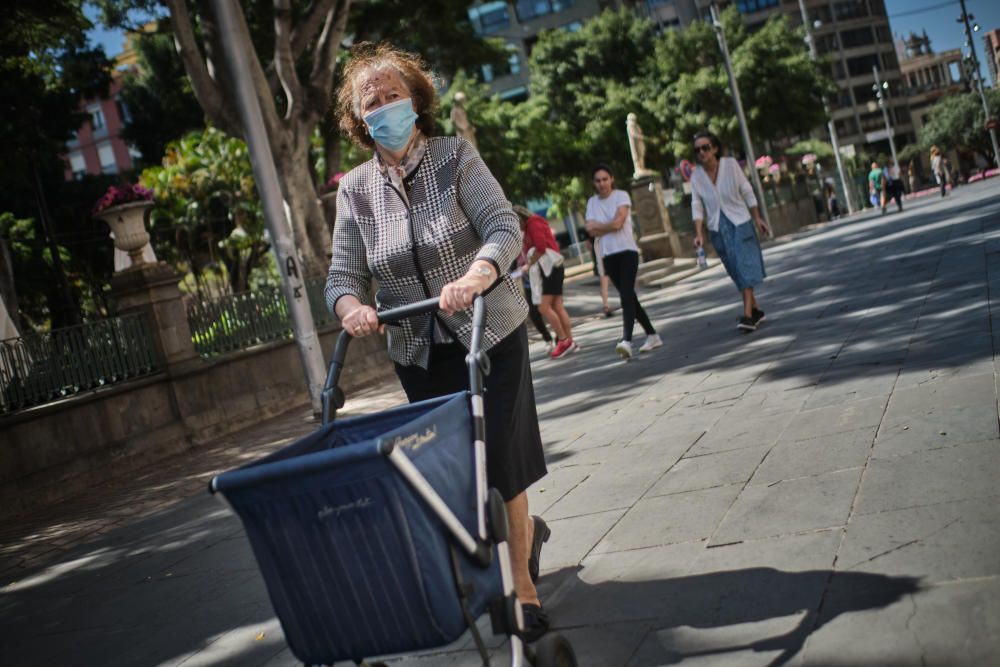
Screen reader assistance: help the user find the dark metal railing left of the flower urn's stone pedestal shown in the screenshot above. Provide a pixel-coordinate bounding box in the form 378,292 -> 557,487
0,313 -> 158,414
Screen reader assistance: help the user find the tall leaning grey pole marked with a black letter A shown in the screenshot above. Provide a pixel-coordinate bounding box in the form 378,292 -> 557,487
212,0 -> 326,414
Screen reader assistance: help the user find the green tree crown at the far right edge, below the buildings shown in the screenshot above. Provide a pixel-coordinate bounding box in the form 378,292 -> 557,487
919,89 -> 1000,161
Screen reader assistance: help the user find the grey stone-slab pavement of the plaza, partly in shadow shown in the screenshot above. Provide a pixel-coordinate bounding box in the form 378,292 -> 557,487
0,179 -> 1000,667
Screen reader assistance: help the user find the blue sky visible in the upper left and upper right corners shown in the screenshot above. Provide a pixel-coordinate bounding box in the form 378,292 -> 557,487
84,0 -> 1000,82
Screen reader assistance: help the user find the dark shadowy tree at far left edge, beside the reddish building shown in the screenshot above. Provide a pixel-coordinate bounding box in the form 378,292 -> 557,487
0,0 -> 110,326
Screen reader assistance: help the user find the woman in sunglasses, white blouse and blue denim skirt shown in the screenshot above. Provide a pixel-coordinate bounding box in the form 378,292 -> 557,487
691,131 -> 768,331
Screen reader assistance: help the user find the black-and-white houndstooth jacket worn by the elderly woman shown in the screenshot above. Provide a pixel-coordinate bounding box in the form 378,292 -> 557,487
325,137 -> 528,368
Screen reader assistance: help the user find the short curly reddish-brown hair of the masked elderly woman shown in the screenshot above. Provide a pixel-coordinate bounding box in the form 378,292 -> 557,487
337,42 -> 438,148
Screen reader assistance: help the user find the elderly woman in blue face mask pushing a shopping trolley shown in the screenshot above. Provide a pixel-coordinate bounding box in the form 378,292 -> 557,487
326,44 -> 549,641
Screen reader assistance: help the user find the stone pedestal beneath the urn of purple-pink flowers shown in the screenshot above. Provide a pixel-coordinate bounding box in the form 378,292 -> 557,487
111,262 -> 198,367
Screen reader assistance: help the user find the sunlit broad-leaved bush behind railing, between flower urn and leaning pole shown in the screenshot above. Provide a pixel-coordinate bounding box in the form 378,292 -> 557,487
142,128 -> 269,293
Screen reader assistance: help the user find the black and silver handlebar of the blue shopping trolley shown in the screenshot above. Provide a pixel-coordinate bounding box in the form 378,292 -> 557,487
320,294 -> 490,425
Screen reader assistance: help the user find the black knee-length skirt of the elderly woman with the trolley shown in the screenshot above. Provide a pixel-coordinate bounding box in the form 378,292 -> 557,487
396,324 -> 546,501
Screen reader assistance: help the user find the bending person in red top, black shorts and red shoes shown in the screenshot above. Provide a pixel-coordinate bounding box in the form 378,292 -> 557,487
514,206 -> 580,359
